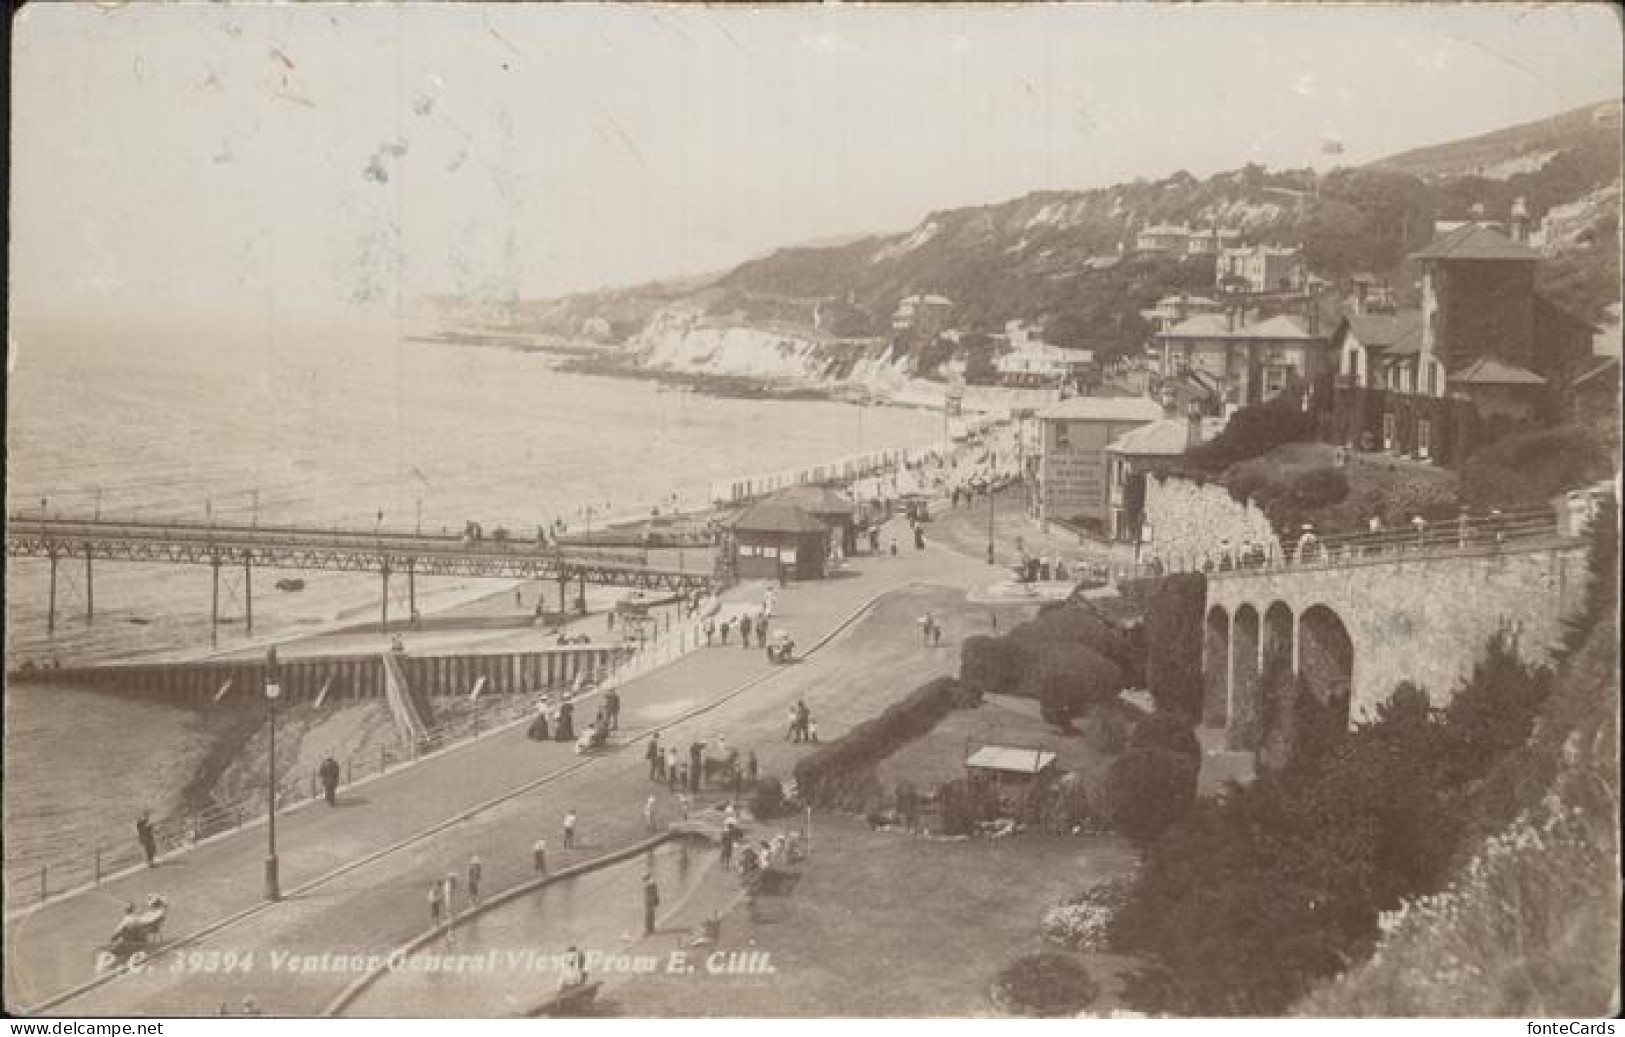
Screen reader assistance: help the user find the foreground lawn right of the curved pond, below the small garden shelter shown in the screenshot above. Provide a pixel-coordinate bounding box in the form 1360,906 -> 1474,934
609,814 -> 1134,1017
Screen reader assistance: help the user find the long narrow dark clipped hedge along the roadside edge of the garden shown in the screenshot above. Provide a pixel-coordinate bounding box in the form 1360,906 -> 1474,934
795,676 -> 960,808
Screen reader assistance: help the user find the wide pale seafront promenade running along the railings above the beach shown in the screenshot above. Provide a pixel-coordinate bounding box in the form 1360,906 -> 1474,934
5,516 -> 1027,1014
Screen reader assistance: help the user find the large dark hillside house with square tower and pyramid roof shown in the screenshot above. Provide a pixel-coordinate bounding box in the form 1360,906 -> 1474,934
1333,221 -> 1593,462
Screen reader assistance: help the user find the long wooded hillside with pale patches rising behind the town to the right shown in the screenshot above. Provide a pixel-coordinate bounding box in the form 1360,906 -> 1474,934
435,106 -> 1620,358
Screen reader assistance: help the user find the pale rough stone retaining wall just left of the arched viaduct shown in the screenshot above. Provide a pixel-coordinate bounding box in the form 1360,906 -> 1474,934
1141,476 -> 1281,569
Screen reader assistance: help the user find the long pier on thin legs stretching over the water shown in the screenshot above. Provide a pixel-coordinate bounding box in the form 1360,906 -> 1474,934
5,515 -> 717,642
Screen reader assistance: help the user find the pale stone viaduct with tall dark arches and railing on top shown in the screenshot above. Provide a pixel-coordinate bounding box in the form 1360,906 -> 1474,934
1203,536 -> 1586,749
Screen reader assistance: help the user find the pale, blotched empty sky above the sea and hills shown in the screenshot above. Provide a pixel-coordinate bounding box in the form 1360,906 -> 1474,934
10,3 -> 1620,328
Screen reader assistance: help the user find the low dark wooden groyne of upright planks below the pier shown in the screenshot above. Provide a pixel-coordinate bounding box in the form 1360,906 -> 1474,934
7,644 -> 627,705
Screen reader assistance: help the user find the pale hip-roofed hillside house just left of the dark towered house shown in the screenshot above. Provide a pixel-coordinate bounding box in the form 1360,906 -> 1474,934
1151,310 -> 1333,406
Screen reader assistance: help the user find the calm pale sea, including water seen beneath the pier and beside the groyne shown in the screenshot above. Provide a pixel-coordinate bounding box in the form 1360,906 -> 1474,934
3,312 -> 943,887
